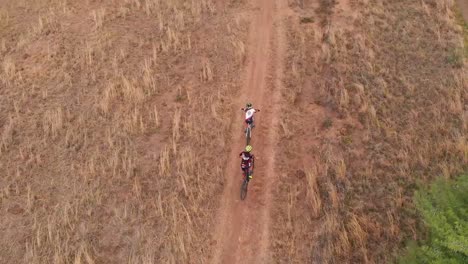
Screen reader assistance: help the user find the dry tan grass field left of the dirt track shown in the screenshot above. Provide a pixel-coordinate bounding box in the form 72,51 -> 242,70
0,0 -> 248,263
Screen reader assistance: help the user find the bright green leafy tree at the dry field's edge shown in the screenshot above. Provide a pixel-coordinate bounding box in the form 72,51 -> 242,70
399,175 -> 468,264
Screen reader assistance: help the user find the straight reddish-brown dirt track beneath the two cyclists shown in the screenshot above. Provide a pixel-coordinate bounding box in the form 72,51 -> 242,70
212,0 -> 287,264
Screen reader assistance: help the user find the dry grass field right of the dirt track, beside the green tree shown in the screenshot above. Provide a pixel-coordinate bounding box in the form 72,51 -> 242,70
272,0 -> 468,263
